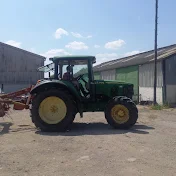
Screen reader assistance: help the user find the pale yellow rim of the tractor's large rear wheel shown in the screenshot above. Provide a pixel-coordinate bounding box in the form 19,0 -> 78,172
39,96 -> 67,124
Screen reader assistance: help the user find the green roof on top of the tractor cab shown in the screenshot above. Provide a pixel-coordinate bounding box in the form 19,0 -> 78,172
49,55 -> 96,62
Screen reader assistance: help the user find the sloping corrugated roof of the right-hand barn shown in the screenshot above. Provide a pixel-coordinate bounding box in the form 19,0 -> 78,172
94,44 -> 176,71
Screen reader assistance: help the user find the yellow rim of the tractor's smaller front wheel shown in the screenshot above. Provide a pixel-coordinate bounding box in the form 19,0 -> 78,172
111,105 -> 129,124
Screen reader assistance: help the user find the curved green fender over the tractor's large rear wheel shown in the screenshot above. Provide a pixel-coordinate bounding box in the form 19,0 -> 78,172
30,80 -> 81,102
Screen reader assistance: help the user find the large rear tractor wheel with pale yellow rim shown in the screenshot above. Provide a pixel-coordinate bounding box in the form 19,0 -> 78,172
31,89 -> 77,131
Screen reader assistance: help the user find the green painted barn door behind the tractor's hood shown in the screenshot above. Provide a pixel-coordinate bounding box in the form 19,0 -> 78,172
116,66 -> 139,101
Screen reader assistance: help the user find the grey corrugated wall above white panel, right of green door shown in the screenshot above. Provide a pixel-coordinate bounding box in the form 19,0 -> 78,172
139,62 -> 163,87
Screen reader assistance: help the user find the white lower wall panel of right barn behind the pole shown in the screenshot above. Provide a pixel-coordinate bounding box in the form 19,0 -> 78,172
139,86 -> 163,104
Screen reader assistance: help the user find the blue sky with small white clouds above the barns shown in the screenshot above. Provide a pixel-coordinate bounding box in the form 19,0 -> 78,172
0,0 -> 176,63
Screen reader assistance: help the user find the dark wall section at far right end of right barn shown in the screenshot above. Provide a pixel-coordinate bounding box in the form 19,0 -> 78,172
165,56 -> 176,104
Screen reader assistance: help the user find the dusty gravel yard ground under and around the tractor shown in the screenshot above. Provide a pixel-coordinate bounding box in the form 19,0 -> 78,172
0,107 -> 176,176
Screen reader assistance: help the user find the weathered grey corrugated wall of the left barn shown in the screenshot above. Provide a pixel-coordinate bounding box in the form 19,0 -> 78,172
0,43 -> 44,84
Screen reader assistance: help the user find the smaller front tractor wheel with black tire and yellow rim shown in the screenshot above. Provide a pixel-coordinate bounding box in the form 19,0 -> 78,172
105,97 -> 138,129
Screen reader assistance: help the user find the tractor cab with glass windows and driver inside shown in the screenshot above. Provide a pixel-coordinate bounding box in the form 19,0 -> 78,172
38,56 -> 95,99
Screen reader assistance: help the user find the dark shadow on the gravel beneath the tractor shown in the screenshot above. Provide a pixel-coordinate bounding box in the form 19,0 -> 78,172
36,122 -> 154,136
